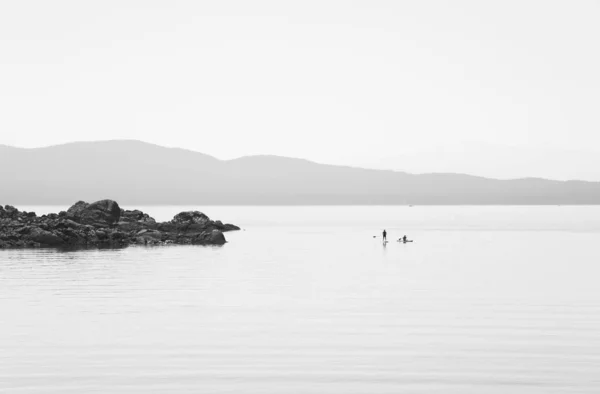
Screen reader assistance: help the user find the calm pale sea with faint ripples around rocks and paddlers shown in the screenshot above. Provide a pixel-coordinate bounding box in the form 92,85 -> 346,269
0,206 -> 600,394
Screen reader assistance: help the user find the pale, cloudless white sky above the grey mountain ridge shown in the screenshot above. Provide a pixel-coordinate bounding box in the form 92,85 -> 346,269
0,0 -> 600,181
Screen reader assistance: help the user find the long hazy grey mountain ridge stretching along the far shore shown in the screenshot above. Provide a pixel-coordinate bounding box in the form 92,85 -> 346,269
0,141 -> 600,205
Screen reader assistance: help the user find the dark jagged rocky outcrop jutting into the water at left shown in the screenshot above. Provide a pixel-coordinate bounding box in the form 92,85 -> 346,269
0,200 -> 240,249
